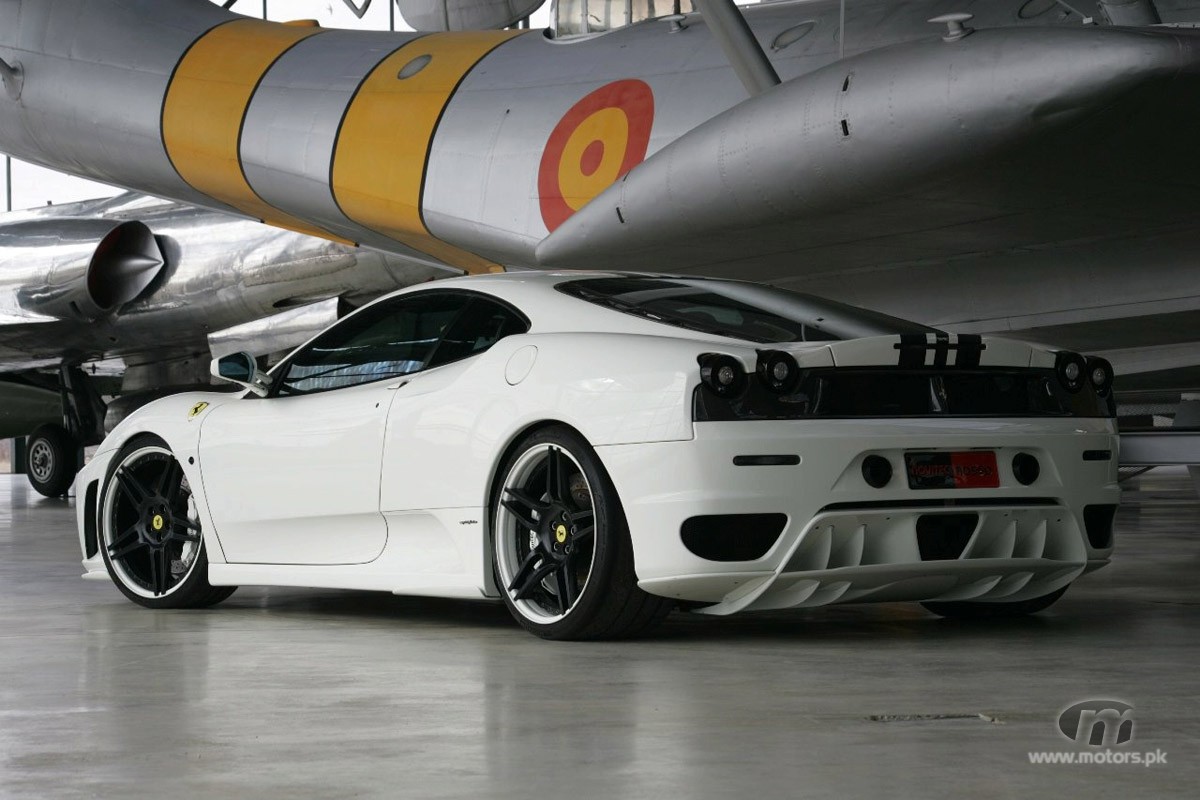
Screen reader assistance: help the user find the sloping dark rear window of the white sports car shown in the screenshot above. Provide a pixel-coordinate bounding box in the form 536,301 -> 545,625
556,276 -> 934,344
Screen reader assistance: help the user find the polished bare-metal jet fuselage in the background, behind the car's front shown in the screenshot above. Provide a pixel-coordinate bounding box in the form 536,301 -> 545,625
0,194 -> 450,375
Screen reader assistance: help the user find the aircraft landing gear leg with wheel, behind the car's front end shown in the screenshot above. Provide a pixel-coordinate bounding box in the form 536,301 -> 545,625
25,365 -> 104,498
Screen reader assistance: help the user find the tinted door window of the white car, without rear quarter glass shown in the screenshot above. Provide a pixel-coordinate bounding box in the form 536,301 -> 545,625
276,293 -> 473,396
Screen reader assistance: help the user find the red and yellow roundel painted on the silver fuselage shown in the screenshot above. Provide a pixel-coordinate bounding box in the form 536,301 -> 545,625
538,80 -> 654,230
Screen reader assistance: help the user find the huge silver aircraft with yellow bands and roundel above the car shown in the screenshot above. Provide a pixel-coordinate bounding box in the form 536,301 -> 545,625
0,0 -> 1200,388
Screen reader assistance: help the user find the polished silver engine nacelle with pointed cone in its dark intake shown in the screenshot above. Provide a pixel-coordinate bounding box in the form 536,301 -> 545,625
8,218 -> 166,321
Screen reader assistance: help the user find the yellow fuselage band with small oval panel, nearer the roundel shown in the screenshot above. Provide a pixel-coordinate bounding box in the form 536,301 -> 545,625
332,31 -> 523,272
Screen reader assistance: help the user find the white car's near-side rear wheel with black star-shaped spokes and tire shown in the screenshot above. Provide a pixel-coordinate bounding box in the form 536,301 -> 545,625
491,426 -> 672,639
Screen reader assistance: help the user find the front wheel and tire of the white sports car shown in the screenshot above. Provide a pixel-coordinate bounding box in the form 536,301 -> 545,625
98,434 -> 236,608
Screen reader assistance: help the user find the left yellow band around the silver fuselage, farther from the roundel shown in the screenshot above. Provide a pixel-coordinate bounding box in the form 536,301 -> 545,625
162,19 -> 352,243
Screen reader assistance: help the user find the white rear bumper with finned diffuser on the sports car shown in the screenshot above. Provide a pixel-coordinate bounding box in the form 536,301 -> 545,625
599,419 -> 1120,613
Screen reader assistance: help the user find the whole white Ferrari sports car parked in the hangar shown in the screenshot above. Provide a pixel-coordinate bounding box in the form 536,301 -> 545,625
77,272 -> 1118,639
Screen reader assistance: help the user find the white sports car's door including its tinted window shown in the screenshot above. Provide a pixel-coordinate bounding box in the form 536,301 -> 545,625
199,291 -> 469,564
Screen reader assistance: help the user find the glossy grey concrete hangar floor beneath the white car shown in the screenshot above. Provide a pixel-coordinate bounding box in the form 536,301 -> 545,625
0,471 -> 1200,800
